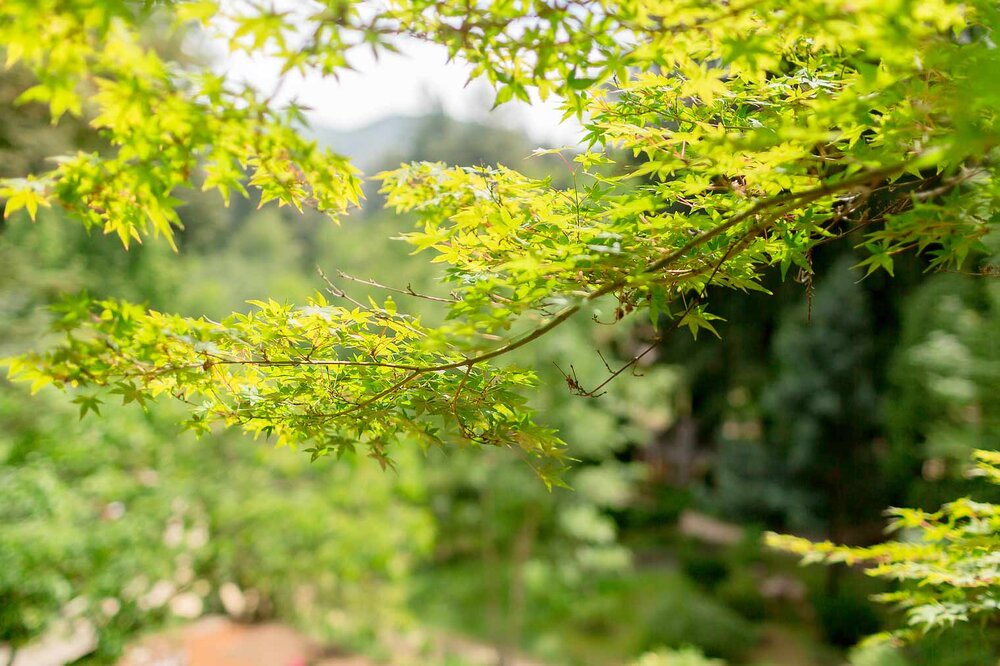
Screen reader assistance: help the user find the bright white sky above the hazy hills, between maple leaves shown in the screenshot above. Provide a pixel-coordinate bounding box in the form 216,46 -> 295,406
220,34 -> 580,146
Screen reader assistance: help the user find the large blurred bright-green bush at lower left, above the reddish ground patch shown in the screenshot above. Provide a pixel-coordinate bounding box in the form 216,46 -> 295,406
0,389 -> 432,663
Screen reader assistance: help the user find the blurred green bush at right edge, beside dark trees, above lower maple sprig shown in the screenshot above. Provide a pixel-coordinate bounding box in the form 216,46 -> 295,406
884,268 -> 1000,508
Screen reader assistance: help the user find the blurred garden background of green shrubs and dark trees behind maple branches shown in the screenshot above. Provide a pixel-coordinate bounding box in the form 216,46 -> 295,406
0,20 -> 1000,666
